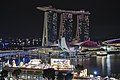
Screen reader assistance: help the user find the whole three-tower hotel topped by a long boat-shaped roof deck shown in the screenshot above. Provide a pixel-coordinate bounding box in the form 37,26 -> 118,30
37,6 -> 90,46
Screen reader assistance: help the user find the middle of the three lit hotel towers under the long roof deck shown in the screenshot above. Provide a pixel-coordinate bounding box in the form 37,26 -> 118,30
59,13 -> 73,42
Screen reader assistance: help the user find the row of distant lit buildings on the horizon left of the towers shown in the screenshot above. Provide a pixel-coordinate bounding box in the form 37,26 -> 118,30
0,38 -> 41,50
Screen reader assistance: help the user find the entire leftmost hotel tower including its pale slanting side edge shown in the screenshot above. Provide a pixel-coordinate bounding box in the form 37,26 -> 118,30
42,11 -> 58,46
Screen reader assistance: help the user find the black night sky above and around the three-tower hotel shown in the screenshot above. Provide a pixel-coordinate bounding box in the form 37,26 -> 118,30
0,0 -> 120,40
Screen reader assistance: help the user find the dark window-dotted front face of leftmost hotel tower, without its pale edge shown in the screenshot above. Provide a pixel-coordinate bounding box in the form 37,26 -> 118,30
47,11 -> 58,45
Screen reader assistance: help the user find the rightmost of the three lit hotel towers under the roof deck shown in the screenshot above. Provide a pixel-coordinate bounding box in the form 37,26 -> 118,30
76,11 -> 90,41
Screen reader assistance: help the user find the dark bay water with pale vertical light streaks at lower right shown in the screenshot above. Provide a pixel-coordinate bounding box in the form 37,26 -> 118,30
88,54 -> 120,76
